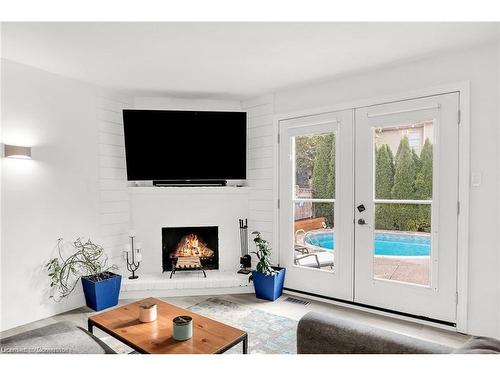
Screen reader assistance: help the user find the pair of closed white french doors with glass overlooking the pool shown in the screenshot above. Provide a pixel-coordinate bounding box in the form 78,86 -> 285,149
279,93 -> 459,322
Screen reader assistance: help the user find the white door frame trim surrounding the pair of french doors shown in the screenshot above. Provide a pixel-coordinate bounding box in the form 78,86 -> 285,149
273,81 -> 470,333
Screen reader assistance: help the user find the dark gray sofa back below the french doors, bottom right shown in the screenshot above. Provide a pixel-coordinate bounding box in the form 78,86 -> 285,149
297,312 -> 500,354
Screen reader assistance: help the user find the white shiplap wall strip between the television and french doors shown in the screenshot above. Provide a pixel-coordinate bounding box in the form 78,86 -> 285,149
241,95 -> 278,261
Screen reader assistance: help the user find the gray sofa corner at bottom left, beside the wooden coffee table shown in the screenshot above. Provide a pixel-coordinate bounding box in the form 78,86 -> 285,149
0,322 -> 115,354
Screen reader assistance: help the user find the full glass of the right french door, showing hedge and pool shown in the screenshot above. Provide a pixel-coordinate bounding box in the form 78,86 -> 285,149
373,121 -> 433,286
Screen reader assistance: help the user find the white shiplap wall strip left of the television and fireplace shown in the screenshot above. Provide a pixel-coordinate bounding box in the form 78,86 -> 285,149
97,91 -> 133,267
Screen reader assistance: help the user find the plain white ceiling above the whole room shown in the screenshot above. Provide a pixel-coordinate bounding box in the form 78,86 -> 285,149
2,23 -> 499,99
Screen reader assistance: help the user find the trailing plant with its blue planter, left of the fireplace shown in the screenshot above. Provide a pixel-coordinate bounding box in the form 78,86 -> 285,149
45,238 -> 122,311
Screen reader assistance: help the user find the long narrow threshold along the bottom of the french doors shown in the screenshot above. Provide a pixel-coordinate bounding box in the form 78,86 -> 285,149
283,288 -> 457,331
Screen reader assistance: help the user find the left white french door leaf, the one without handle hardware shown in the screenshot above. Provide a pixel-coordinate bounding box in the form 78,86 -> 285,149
279,111 -> 354,300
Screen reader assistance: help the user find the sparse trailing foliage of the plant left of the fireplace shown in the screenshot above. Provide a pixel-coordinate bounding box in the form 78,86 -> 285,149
45,238 -> 117,302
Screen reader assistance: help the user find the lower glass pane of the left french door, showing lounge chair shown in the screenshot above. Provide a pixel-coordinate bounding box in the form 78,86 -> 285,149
294,201 -> 335,271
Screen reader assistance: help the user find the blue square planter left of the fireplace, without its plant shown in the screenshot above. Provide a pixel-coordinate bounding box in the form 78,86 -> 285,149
82,272 -> 122,311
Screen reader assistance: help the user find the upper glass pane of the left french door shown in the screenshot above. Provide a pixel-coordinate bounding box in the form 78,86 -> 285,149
294,132 -> 336,199
